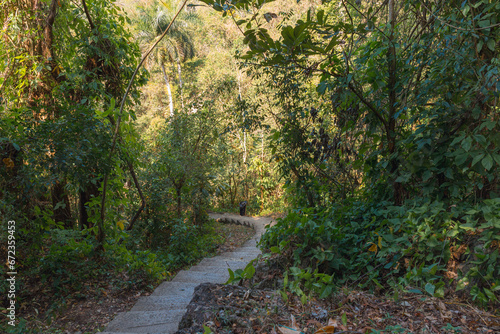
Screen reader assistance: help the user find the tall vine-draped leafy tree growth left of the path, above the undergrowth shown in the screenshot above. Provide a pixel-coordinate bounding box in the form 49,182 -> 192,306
0,0 -> 145,243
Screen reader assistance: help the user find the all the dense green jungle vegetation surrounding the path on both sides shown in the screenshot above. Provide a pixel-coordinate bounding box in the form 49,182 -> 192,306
0,0 -> 500,332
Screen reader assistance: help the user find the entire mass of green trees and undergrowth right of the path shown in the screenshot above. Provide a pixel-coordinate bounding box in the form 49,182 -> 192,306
196,0 -> 500,305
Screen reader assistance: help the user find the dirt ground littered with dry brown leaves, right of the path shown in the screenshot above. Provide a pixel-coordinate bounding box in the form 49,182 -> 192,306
176,254 -> 500,334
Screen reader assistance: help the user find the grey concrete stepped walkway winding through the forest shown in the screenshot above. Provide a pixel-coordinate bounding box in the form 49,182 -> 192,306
104,214 -> 272,334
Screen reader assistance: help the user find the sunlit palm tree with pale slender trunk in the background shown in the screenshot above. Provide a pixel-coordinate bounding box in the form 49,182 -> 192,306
136,0 -> 198,116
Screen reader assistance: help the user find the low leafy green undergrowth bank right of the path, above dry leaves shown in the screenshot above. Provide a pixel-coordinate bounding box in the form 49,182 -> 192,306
262,199 -> 500,310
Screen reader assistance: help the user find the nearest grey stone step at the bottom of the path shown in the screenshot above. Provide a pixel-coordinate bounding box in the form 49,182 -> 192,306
106,308 -> 186,334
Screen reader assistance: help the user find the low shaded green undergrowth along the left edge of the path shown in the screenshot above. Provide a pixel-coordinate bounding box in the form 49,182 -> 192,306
0,220 -> 225,333
